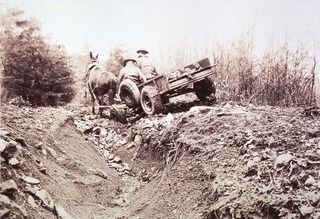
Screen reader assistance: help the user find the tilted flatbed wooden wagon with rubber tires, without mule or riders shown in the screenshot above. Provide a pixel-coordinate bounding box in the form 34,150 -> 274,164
119,58 -> 216,115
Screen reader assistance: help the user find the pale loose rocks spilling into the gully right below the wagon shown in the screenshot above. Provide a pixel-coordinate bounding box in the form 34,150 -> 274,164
74,109 -> 174,180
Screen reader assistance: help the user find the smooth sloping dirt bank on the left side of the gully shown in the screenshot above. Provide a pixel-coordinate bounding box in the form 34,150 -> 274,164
1,106 -> 122,218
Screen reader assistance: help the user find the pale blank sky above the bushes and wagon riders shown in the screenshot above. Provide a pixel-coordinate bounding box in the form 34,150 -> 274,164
0,0 -> 320,65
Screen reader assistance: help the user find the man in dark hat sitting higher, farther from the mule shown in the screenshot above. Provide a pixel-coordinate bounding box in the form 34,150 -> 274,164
137,49 -> 158,79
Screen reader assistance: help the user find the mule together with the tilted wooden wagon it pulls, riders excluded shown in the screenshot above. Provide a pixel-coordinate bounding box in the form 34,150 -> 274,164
88,53 -> 216,123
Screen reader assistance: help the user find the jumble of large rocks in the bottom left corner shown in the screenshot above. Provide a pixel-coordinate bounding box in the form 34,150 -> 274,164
0,126 -> 72,219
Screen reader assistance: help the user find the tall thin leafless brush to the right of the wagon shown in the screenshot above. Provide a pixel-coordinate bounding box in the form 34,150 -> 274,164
214,38 -> 316,106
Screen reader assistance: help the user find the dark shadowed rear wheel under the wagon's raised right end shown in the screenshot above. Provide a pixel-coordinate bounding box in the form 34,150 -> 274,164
194,76 -> 216,101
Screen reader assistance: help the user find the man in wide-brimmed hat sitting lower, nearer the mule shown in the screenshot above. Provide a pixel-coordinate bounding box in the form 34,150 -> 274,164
119,58 -> 146,84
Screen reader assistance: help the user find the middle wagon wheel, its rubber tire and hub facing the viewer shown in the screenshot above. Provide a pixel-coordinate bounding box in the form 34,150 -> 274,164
140,85 -> 163,115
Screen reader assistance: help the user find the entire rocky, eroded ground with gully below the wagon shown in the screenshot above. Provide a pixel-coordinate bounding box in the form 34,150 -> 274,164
0,103 -> 320,218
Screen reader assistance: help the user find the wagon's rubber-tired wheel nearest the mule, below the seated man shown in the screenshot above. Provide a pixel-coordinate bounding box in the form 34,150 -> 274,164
120,79 -> 140,108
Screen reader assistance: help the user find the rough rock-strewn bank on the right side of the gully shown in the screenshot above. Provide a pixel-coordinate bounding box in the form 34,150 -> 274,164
171,104 -> 320,218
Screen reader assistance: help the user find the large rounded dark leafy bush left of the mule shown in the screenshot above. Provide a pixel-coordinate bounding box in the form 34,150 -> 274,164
0,10 -> 75,106
